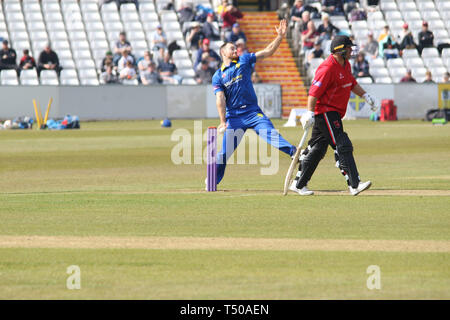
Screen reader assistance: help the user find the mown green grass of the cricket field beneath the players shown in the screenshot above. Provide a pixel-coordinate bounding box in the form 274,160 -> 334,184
0,120 -> 450,299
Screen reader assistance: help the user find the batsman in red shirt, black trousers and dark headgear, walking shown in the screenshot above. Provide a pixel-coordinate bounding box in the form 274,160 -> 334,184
289,36 -> 379,196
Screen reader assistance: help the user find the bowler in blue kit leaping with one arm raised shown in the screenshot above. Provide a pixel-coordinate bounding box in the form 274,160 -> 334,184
212,20 -> 296,188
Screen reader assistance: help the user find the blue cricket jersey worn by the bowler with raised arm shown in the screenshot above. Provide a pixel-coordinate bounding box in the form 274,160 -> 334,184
212,53 -> 259,117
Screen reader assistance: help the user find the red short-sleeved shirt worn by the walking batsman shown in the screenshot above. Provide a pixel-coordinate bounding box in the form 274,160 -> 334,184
309,54 -> 357,118
